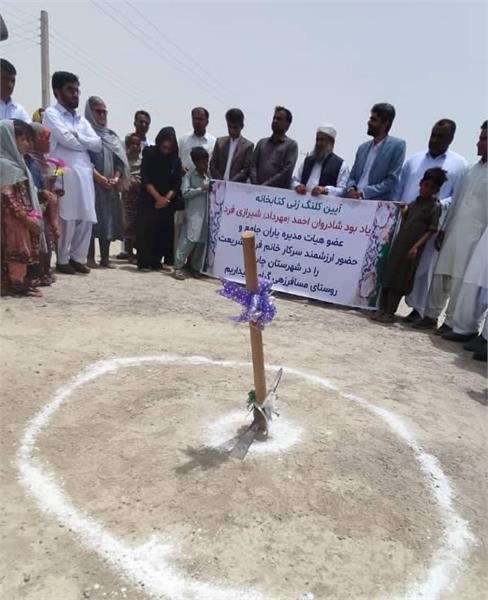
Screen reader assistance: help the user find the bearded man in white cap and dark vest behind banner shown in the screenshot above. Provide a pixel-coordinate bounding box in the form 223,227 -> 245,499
291,123 -> 349,196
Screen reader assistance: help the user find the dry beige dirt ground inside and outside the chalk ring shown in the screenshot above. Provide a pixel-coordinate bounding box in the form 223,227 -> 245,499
0,263 -> 488,600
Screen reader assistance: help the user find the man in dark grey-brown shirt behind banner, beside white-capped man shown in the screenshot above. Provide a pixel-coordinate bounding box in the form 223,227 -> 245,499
250,106 -> 298,189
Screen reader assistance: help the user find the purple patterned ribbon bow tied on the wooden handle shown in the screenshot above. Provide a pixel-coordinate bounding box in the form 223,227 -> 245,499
218,277 -> 276,329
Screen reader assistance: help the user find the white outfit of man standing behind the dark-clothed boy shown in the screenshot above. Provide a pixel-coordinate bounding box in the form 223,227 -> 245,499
395,150 -> 468,314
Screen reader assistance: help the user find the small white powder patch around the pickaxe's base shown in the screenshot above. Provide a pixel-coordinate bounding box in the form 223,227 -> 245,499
205,410 -> 303,455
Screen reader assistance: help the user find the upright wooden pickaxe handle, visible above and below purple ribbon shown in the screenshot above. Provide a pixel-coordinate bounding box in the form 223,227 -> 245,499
242,231 -> 266,429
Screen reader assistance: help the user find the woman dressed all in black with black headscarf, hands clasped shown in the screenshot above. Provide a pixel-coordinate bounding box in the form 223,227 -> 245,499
136,127 -> 181,271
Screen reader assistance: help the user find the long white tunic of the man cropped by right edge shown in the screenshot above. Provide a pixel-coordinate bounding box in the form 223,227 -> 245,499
434,161 -> 488,279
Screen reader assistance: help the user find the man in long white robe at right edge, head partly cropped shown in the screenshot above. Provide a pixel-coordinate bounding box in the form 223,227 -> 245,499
414,121 -> 488,335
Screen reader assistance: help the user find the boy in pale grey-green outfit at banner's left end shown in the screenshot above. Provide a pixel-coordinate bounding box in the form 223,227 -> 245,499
173,146 -> 210,280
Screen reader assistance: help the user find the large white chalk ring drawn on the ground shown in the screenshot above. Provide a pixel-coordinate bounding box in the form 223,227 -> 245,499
17,354 -> 475,600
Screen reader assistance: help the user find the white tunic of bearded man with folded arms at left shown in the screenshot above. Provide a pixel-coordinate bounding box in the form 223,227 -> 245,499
42,103 -> 102,223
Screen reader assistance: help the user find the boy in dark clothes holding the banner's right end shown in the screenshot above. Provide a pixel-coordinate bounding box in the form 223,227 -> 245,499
371,167 -> 447,323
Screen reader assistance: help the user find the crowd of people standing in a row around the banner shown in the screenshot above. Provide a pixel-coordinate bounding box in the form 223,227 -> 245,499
0,59 -> 488,360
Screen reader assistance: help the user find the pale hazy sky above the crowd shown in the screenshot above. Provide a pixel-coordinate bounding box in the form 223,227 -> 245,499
0,0 -> 488,165
